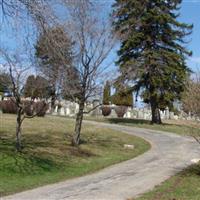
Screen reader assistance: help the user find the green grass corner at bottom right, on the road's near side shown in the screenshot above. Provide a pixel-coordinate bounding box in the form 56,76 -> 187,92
136,164 -> 200,200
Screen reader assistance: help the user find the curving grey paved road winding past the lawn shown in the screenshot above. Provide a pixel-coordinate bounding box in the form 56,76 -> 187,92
3,121 -> 200,200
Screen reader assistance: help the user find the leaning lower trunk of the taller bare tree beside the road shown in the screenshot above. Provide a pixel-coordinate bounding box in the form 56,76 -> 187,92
72,102 -> 84,146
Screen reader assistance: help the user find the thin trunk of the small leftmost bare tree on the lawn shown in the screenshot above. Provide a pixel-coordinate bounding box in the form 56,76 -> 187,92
16,108 -> 22,151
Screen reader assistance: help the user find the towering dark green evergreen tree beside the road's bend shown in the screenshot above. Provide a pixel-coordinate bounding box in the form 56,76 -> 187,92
113,0 -> 192,123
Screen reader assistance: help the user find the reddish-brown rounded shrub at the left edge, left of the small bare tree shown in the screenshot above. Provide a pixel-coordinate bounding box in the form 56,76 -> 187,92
0,100 -> 17,114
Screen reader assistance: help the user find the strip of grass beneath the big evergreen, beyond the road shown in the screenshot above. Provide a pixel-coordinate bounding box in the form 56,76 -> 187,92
85,117 -> 200,135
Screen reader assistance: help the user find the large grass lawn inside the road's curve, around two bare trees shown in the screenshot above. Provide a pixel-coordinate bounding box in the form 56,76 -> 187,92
0,114 -> 150,197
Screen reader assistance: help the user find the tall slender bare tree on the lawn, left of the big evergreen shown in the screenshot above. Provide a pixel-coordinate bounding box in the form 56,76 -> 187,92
63,0 -> 115,145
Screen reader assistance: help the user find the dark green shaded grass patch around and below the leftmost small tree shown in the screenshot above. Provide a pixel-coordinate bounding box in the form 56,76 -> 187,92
0,134 -> 64,176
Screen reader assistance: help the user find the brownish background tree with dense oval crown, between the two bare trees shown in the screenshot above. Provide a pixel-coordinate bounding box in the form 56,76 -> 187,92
35,26 -> 73,111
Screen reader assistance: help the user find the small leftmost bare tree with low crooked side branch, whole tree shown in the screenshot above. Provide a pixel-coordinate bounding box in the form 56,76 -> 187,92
0,49 -> 47,151
